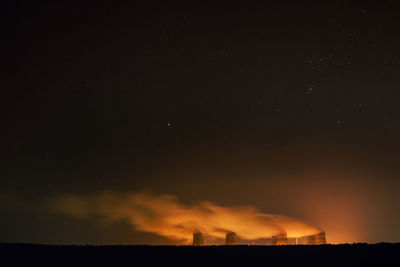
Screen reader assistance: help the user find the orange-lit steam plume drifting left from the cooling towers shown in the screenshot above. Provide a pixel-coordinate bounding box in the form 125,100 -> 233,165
51,192 -> 322,243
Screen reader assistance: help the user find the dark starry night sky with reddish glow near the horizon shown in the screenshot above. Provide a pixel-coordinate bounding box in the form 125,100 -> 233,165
0,1 -> 400,244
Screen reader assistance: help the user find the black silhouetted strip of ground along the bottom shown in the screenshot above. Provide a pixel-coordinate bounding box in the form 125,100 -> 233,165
0,243 -> 400,266
